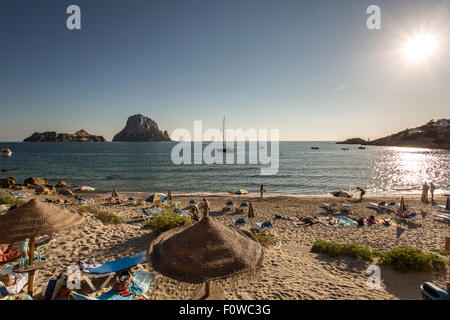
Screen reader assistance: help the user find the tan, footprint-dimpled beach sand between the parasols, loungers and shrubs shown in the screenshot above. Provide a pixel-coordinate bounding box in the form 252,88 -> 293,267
0,190 -> 449,300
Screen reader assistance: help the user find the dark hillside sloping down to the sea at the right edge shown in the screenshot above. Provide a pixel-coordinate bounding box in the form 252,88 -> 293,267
366,119 -> 450,149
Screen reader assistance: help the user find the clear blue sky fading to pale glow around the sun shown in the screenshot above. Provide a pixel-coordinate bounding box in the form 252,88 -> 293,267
0,0 -> 450,141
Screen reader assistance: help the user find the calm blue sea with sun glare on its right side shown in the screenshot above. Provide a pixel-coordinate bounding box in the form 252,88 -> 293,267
0,142 -> 450,195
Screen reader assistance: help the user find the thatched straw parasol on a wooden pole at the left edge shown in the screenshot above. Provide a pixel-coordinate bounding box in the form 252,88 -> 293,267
0,199 -> 84,296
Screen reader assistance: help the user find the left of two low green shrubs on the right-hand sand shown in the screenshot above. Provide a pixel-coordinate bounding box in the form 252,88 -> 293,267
311,241 -> 373,261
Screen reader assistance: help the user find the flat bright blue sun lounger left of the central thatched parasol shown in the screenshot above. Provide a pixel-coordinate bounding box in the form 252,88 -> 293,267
81,251 -> 148,291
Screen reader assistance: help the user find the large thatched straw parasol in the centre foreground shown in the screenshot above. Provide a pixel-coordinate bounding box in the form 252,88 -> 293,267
148,216 -> 263,298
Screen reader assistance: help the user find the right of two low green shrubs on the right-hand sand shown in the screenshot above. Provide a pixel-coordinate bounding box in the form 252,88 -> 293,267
380,247 -> 446,272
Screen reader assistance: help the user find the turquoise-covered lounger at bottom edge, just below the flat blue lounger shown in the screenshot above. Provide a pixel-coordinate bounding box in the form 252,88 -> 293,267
72,270 -> 156,300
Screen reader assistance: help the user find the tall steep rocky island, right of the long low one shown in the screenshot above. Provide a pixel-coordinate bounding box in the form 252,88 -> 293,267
112,114 -> 171,142
